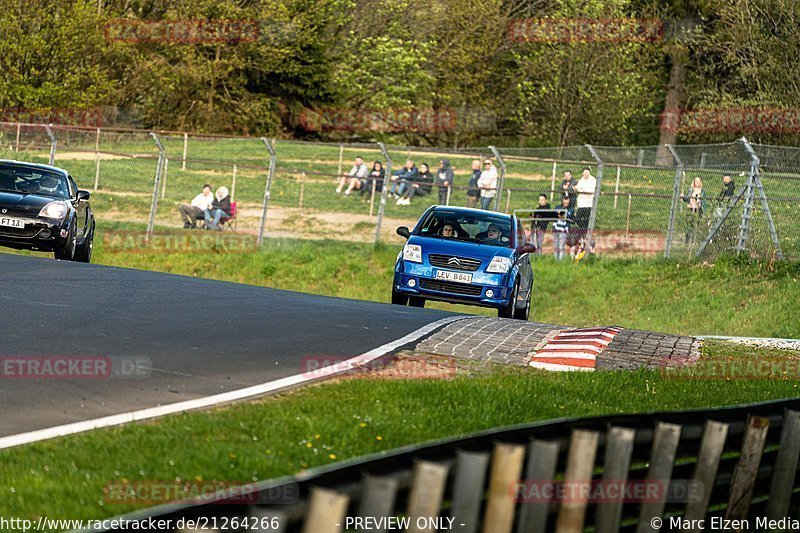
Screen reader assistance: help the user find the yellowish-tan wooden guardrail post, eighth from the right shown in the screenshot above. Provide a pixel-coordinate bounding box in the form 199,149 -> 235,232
483,444 -> 525,533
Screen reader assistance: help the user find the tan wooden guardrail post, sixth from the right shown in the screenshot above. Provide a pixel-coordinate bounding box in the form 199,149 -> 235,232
556,429 -> 600,533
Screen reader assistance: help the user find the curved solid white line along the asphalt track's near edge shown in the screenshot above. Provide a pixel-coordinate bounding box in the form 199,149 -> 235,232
0,316 -> 465,450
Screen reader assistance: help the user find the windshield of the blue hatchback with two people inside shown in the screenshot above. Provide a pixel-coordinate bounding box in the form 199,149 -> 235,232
418,209 -> 512,248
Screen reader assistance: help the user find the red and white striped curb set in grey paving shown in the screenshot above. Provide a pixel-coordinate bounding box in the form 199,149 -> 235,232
529,326 -> 622,372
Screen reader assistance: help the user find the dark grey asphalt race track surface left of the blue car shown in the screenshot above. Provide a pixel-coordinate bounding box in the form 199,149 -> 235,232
0,253 -> 452,437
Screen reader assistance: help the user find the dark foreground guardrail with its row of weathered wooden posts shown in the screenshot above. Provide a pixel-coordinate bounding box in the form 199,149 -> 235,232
79,399 -> 800,533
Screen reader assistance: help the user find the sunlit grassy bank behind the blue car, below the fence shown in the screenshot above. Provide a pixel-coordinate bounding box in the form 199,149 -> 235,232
87,232 -> 800,338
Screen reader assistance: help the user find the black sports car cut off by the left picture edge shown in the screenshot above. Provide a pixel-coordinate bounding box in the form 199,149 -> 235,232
0,160 -> 94,263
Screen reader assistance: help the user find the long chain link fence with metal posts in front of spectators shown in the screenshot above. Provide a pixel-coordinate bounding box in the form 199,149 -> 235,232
0,123 -> 800,260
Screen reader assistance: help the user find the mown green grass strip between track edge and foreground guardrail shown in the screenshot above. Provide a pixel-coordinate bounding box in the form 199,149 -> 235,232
0,343 -> 798,519
